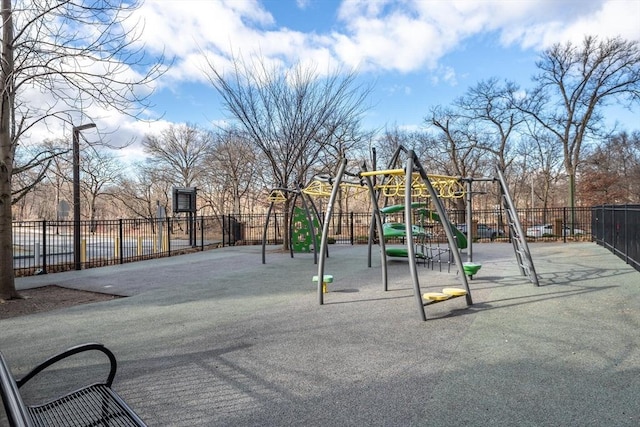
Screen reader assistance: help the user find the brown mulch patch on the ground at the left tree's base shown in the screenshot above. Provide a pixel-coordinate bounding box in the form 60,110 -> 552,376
0,285 -> 121,319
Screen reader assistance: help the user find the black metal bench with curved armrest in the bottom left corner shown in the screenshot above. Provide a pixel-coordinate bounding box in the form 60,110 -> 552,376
0,343 -> 146,427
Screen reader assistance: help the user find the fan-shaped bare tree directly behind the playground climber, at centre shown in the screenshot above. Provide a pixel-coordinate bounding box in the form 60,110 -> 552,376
207,59 -> 370,248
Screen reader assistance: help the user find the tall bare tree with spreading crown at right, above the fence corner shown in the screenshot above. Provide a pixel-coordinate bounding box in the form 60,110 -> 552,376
519,36 -> 640,226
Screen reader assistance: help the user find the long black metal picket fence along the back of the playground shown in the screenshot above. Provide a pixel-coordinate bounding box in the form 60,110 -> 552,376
13,208 -> 592,276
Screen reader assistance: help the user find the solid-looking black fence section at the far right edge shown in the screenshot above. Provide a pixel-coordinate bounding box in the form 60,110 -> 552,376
591,205 -> 640,271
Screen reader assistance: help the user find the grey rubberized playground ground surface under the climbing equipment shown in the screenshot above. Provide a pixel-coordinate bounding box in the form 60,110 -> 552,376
0,243 -> 640,426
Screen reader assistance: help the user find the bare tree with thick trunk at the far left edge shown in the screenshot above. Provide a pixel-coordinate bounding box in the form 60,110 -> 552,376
0,0 -> 168,299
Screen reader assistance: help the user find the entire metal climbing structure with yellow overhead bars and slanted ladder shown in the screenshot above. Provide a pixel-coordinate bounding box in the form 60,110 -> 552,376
262,146 -> 538,321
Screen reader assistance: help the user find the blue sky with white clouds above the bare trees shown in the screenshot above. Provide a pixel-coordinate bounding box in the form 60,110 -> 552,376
30,0 -> 640,155
